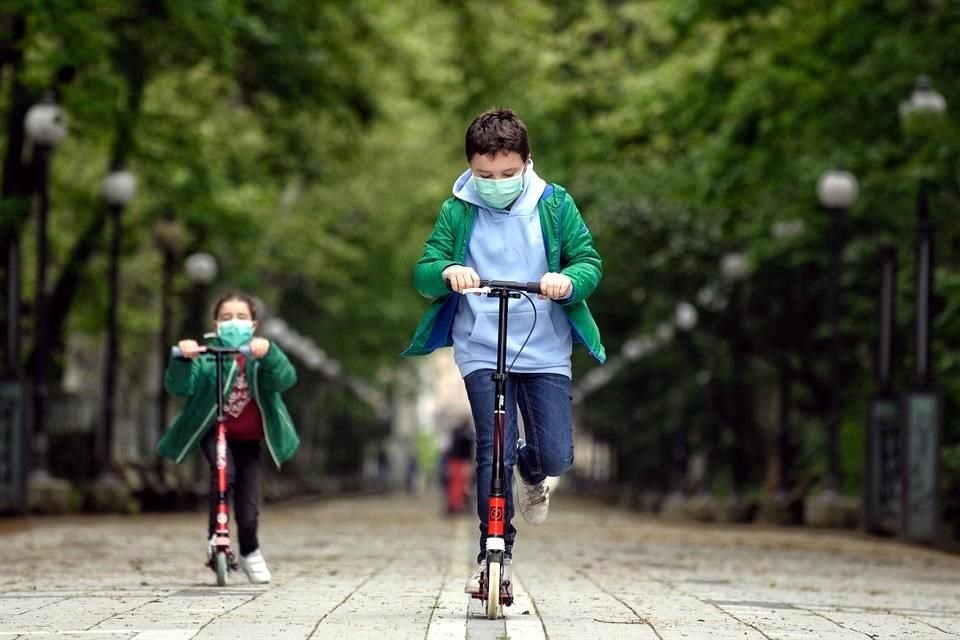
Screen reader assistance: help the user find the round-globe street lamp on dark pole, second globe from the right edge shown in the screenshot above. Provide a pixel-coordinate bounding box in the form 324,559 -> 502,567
817,169 -> 860,494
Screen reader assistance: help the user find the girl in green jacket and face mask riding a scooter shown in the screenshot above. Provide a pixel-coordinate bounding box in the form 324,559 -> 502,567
157,293 -> 300,584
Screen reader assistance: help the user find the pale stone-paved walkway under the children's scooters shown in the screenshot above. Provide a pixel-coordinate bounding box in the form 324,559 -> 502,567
0,490 -> 960,640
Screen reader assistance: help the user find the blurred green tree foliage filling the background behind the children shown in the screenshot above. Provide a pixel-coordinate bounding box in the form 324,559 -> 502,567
0,0 -> 960,516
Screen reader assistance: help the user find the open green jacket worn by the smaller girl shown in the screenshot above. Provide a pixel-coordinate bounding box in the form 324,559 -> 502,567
157,339 -> 300,467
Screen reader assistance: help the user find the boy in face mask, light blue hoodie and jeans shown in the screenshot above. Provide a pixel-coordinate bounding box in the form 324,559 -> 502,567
404,109 -> 605,594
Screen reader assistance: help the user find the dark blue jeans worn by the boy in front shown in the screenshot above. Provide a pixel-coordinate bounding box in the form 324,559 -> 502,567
463,369 -> 573,560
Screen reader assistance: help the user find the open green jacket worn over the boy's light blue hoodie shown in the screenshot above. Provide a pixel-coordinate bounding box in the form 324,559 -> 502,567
402,184 -> 607,362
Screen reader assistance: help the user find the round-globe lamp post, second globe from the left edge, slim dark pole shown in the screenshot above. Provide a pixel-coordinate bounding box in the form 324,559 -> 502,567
98,167 -> 137,477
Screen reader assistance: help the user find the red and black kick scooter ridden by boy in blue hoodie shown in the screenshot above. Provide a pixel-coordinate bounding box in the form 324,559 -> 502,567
462,280 -> 540,620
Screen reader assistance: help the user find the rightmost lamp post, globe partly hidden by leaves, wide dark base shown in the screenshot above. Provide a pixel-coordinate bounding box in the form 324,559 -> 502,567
899,76 -> 947,542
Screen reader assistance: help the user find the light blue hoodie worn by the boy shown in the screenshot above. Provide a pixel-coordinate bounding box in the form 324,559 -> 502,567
453,160 -> 573,378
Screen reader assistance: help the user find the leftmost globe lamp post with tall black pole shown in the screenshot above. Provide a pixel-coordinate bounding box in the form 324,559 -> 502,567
23,93 -> 67,481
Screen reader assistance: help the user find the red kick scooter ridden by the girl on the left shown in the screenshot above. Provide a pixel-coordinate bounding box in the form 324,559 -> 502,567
170,346 -> 250,587
